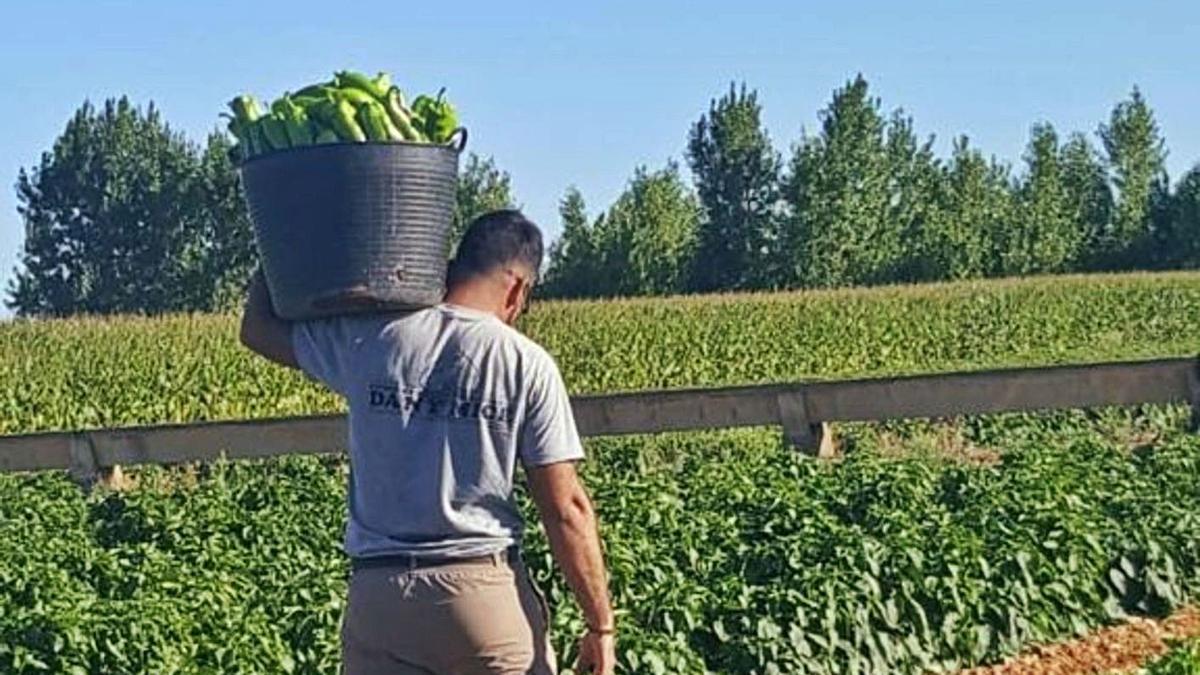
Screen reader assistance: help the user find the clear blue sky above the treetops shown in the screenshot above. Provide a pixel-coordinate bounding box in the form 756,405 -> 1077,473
0,0 -> 1200,313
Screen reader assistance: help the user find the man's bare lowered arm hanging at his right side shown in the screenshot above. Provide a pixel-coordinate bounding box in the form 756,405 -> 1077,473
526,462 -> 614,633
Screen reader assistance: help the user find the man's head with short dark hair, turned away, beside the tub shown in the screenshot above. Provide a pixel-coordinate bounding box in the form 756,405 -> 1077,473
446,209 -> 542,324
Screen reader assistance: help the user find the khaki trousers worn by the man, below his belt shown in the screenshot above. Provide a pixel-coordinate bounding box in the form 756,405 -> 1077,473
342,555 -> 557,675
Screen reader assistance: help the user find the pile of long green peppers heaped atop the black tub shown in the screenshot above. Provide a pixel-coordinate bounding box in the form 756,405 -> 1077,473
223,71 -> 458,161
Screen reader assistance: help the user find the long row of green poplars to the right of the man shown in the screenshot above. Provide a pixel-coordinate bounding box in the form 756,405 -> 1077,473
546,76 -> 1200,297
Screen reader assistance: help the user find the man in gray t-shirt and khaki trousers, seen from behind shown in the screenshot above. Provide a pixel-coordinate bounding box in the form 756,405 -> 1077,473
241,210 -> 616,675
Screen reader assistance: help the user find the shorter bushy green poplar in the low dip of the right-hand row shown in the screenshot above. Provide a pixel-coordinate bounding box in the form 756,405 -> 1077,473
920,136 -> 1013,279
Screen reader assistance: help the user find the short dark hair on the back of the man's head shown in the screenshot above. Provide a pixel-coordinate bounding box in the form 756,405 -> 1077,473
446,209 -> 542,286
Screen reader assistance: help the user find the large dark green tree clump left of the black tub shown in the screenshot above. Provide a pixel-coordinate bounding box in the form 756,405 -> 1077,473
7,97 -> 253,316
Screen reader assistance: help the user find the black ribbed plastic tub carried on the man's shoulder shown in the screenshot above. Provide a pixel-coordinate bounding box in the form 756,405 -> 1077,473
241,130 -> 466,321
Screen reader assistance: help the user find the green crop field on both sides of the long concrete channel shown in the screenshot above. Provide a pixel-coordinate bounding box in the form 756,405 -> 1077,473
0,274 -> 1200,674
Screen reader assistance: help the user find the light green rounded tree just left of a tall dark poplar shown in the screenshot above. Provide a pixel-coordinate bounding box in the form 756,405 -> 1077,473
590,163 -> 700,295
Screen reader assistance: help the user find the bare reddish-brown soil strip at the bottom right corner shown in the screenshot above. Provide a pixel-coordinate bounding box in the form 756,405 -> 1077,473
959,607 -> 1200,675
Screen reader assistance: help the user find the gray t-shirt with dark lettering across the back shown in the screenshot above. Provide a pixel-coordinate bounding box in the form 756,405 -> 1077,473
292,304 -> 583,557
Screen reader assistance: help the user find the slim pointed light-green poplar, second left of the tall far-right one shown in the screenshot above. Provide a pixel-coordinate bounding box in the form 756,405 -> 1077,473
997,124 -> 1084,275
